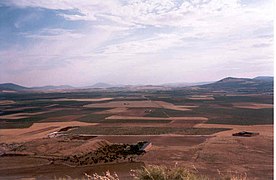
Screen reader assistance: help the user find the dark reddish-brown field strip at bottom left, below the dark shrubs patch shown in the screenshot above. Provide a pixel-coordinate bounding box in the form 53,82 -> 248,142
0,157 -> 144,180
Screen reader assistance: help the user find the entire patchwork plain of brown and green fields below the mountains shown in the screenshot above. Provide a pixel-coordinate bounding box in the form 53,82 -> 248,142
0,89 -> 273,179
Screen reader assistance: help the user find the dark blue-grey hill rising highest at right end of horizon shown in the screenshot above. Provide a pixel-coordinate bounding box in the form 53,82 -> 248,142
199,76 -> 274,93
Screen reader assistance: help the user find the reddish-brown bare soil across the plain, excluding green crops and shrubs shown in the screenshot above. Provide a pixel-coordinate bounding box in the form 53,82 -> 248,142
0,95 -> 273,179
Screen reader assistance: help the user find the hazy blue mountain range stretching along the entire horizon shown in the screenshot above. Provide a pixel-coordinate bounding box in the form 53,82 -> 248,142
0,76 -> 274,92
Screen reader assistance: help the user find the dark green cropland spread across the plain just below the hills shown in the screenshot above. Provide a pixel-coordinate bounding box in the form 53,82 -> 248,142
0,89 -> 273,129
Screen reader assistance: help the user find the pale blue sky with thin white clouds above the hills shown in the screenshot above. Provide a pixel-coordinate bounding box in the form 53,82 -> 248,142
0,0 -> 274,86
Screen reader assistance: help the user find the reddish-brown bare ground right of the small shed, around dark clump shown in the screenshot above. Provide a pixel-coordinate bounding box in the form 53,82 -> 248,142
140,124 -> 273,179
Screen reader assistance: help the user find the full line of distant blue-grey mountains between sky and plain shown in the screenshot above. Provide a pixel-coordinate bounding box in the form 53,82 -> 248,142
0,76 -> 274,94
